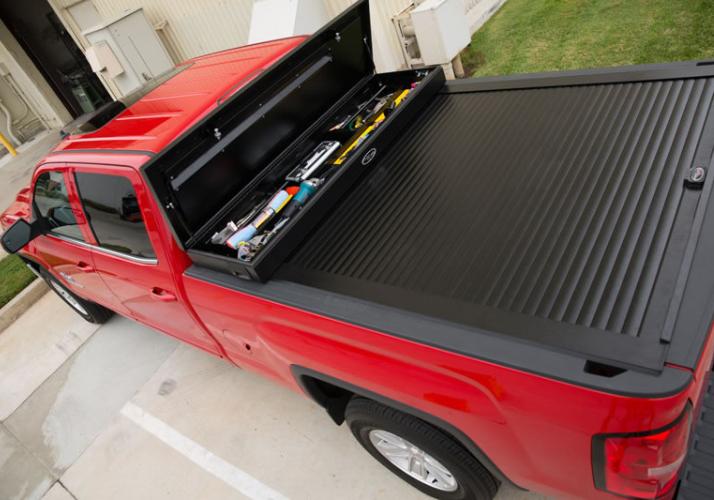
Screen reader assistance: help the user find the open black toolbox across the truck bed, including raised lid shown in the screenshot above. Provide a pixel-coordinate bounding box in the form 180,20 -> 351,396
144,0 -> 444,281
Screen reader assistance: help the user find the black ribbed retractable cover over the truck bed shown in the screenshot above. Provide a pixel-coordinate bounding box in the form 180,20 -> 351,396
276,64 -> 714,371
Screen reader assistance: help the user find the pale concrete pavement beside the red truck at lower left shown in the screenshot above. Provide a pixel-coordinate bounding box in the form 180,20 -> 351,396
0,294 -> 539,500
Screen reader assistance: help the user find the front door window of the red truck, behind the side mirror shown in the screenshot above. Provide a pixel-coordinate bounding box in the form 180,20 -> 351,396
33,172 -> 84,241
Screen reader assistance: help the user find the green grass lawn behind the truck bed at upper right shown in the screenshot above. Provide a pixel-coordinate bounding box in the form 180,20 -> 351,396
462,0 -> 714,76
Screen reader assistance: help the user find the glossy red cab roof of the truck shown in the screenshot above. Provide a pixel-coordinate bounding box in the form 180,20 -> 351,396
54,36 -> 306,160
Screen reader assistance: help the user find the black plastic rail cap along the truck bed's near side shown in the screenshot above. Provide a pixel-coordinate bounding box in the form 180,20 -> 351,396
184,265 -> 692,398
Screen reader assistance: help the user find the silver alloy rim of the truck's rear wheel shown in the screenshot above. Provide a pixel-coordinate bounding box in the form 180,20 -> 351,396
369,429 -> 459,492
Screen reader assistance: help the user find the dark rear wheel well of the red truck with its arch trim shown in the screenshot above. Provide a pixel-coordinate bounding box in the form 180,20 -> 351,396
291,365 -> 525,491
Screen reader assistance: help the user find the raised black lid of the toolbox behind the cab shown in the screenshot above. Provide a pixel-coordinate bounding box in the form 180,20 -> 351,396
143,0 -> 375,247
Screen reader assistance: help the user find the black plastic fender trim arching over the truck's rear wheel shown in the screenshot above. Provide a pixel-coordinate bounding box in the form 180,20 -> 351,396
290,365 -> 525,491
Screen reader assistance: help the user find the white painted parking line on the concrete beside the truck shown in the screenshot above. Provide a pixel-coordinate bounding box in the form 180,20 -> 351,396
121,403 -> 287,500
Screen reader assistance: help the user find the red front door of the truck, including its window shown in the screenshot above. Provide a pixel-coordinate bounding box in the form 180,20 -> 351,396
32,167 -> 113,307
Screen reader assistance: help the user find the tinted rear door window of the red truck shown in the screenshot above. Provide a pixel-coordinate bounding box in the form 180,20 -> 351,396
76,172 -> 156,258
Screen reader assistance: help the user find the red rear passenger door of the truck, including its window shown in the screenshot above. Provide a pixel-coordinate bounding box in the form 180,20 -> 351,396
73,166 -> 218,353
